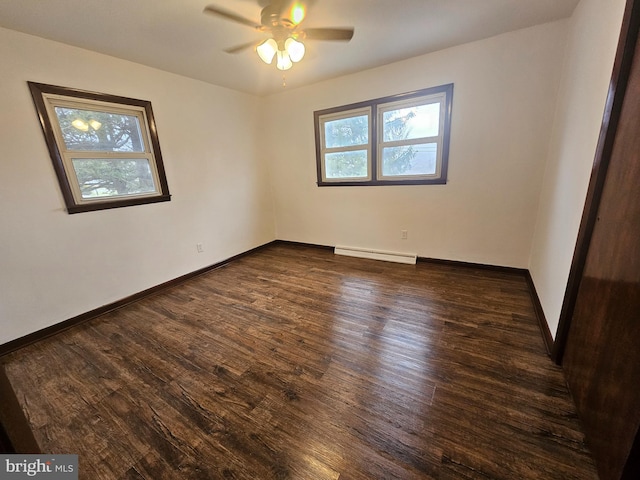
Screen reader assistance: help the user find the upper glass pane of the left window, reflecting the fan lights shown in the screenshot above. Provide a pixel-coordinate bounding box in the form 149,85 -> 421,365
55,107 -> 144,152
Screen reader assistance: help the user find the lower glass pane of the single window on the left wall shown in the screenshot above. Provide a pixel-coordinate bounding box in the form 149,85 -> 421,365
72,158 -> 157,199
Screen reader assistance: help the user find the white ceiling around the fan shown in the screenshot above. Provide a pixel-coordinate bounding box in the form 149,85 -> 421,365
0,0 -> 579,95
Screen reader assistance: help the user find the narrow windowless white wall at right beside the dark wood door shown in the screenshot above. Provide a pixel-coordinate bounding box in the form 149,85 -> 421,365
529,0 -> 625,337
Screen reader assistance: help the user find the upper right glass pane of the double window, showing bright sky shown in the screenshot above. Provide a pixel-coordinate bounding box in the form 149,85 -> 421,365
382,103 -> 440,142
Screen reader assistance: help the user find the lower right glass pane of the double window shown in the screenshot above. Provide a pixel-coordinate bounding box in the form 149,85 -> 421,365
382,143 -> 438,176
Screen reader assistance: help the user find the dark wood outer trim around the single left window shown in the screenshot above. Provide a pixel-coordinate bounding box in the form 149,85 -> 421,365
27,82 -> 171,213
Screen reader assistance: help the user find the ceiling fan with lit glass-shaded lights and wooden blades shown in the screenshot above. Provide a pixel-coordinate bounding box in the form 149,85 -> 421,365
204,0 -> 354,70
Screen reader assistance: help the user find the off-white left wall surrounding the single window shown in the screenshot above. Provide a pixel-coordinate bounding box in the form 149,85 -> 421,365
0,29 -> 275,344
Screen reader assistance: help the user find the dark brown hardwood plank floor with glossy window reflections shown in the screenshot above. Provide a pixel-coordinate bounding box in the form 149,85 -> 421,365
2,244 -> 597,480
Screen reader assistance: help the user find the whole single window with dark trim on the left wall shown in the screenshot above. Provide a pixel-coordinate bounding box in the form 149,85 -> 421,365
28,82 -> 171,213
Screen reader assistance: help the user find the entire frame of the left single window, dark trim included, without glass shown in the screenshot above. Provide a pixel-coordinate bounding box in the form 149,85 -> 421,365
28,82 -> 171,213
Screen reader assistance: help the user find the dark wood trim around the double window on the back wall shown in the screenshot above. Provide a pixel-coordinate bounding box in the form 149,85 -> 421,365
313,83 -> 453,187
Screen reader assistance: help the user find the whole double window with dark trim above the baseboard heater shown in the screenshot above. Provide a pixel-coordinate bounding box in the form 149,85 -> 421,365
314,84 -> 453,186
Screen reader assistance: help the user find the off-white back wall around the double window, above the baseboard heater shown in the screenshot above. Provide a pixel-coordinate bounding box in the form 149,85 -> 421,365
265,21 -> 567,268
